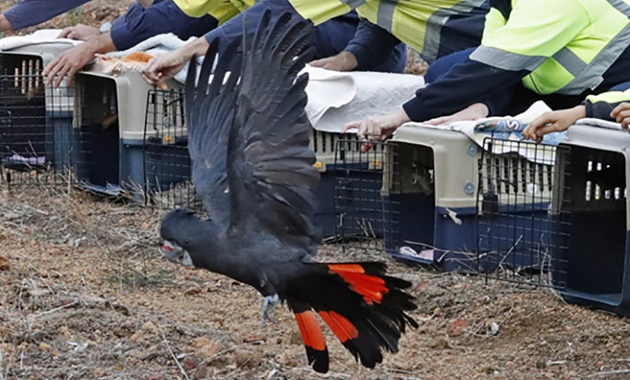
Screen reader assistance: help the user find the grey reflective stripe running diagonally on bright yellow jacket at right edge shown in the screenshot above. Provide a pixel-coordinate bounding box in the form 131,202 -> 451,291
558,22 -> 630,95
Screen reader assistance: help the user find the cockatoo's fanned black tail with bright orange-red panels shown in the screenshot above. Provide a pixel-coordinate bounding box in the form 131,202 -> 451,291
286,262 -> 418,372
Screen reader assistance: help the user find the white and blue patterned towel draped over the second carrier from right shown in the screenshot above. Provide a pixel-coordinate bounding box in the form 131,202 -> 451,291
403,101 -> 567,165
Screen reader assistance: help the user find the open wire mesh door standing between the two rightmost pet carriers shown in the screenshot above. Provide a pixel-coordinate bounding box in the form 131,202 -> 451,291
477,138 -> 557,284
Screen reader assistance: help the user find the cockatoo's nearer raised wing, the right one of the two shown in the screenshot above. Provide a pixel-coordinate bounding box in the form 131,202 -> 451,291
227,12 -> 319,250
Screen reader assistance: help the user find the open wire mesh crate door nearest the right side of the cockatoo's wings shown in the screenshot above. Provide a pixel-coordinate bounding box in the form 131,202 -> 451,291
333,138 -> 387,252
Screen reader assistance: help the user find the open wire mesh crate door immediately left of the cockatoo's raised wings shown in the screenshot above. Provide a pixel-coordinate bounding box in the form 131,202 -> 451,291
143,89 -> 202,210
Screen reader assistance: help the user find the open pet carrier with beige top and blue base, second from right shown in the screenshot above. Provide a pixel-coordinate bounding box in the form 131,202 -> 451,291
385,126 -> 547,272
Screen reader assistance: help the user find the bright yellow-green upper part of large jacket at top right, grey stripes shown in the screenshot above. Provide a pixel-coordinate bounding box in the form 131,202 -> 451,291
470,0 -> 630,95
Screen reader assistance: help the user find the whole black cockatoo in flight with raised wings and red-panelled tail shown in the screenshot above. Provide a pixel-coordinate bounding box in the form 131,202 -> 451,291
160,11 -> 418,373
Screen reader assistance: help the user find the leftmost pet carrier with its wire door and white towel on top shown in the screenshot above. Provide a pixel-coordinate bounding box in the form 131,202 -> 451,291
0,43 -> 74,184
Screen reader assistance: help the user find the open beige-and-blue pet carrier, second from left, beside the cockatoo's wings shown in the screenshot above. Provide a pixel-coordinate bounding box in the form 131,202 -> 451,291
75,65 -> 185,198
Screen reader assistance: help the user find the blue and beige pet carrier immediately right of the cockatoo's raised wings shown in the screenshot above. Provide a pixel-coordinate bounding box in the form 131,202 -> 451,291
311,129 -> 385,238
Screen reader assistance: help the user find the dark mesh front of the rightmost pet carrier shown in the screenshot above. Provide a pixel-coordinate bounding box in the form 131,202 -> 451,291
556,146 -> 628,298
